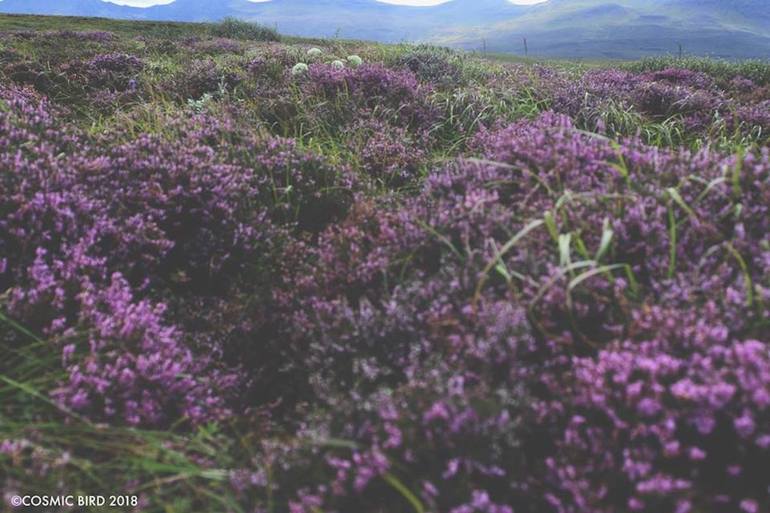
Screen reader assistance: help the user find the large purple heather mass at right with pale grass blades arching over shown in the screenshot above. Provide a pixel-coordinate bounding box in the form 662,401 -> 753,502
266,114 -> 770,512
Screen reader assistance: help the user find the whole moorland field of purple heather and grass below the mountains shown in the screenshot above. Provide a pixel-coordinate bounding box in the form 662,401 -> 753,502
0,20 -> 770,513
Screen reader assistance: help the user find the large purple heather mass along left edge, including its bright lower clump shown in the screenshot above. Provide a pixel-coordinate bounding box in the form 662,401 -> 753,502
0,86 -> 355,425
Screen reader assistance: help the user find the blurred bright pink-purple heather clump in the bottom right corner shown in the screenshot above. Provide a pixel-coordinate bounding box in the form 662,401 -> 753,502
543,312 -> 770,512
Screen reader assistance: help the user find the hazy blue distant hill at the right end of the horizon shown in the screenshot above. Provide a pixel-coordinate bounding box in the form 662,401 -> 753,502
436,0 -> 770,59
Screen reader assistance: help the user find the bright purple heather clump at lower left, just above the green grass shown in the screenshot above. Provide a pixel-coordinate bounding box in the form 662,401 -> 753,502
53,273 -> 235,426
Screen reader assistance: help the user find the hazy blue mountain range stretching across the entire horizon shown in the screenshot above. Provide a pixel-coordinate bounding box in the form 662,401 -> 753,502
0,0 -> 770,59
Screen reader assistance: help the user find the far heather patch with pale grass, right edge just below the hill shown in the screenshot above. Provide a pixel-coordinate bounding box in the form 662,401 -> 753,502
539,67 -> 767,146
